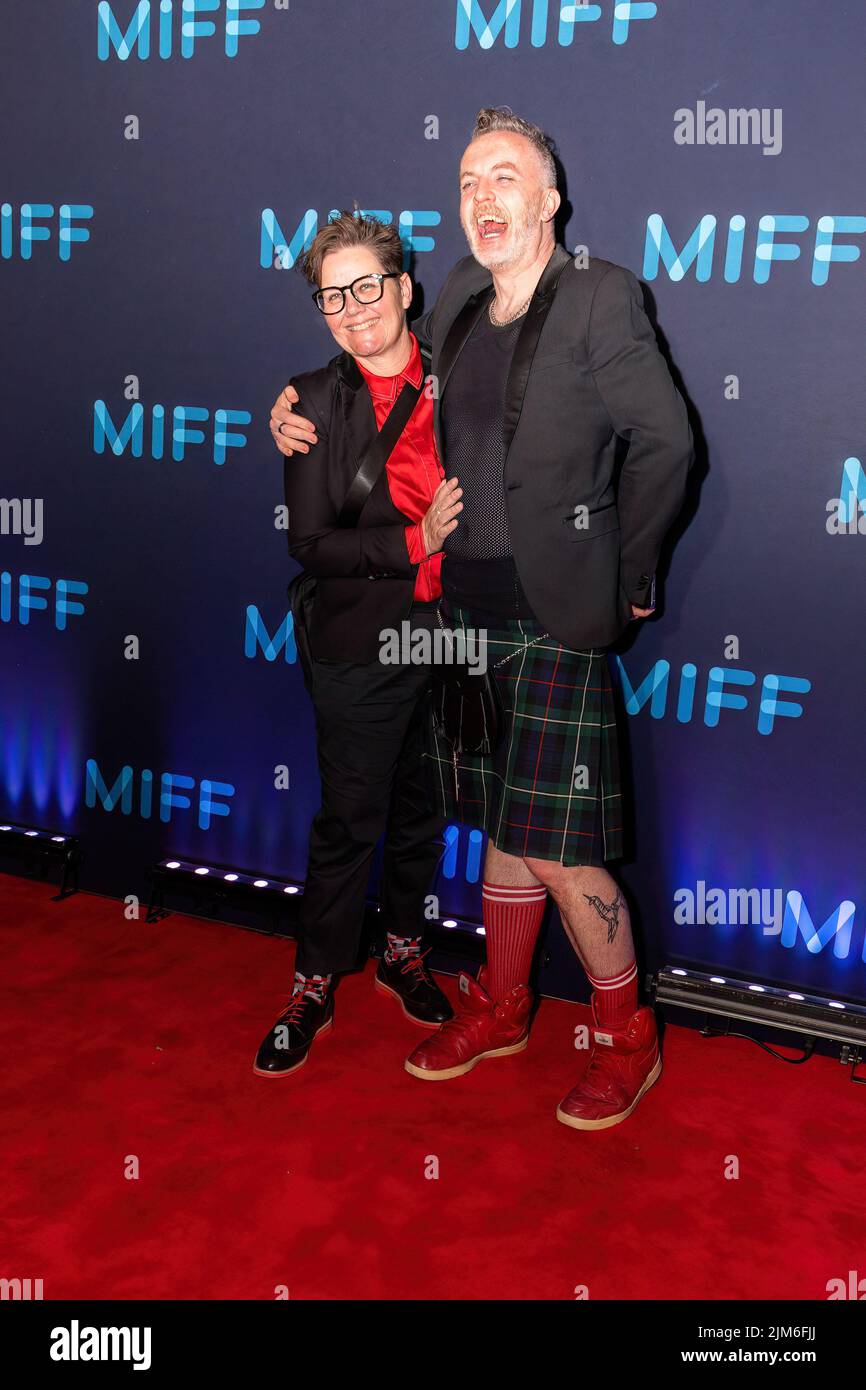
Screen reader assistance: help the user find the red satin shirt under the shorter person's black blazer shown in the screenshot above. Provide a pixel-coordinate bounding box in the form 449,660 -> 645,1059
356,332 -> 445,600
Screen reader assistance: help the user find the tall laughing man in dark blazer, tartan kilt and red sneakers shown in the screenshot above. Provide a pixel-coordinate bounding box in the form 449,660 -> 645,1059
271,108 -> 694,1129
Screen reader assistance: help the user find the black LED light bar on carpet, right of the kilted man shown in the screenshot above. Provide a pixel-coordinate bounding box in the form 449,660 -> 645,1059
651,966 -> 866,1083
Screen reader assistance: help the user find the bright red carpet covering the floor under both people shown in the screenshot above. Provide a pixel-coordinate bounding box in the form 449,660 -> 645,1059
0,876 -> 866,1300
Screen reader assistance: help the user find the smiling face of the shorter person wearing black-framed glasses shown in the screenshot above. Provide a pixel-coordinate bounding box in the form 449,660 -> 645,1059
320,246 -> 411,359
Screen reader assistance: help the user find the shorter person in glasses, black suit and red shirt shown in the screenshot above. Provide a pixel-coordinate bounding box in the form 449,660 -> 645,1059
254,213 -> 461,1077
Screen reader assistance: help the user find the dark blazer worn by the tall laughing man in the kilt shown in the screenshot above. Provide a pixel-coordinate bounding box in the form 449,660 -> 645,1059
413,246 -> 694,649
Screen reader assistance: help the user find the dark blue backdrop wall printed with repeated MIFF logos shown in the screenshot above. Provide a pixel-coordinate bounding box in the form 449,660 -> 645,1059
0,0 -> 866,999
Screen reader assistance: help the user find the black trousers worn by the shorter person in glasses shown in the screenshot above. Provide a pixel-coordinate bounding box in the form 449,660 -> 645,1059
296,603 -> 445,974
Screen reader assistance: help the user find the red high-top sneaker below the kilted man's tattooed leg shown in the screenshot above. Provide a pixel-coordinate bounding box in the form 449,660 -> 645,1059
556,994 -> 662,1129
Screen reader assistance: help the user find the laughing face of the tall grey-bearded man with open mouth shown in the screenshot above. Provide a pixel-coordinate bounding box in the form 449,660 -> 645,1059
460,131 -> 559,270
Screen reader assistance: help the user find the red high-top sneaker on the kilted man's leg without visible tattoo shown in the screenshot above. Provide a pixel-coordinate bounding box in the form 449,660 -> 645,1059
406,966 -> 532,1081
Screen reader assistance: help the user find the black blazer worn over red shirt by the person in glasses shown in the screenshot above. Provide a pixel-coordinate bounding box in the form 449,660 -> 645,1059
284,352 -> 430,662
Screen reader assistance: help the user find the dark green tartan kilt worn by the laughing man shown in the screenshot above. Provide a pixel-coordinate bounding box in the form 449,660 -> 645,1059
425,600 -> 623,866
